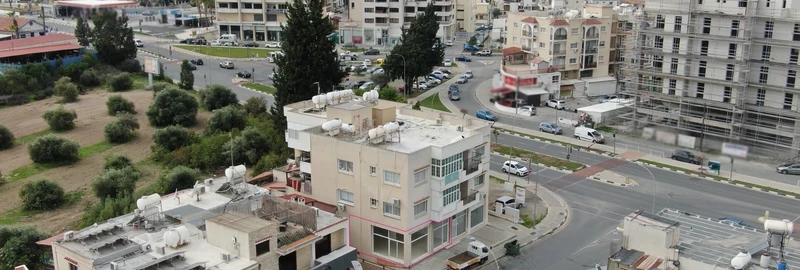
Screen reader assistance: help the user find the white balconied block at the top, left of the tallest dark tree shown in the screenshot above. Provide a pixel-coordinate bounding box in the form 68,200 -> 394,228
215,0 -> 290,41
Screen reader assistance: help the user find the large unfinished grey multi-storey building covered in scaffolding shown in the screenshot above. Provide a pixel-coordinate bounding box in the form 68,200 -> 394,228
623,0 -> 800,154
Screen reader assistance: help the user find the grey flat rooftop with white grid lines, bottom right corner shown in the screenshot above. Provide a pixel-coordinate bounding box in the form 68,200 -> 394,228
658,209 -> 800,269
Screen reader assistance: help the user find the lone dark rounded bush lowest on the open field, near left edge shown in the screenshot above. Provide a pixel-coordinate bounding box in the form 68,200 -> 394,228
19,180 -> 67,210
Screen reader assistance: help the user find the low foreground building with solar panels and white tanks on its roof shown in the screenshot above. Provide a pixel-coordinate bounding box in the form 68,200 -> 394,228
43,173 -> 356,270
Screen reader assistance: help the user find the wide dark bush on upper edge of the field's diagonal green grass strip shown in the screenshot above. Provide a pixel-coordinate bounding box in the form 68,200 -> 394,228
28,134 -> 80,163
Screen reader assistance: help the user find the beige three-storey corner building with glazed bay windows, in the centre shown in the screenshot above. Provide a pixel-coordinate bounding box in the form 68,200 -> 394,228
284,90 -> 491,268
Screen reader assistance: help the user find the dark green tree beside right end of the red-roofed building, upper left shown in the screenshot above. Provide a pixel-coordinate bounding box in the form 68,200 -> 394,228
92,11 -> 136,64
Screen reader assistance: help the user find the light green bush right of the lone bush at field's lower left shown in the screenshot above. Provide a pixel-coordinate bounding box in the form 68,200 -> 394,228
92,167 -> 140,199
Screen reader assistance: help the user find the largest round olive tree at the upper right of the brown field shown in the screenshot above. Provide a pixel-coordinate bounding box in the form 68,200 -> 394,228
146,88 -> 197,127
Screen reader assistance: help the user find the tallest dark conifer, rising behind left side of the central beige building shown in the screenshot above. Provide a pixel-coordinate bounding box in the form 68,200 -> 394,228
271,0 -> 344,130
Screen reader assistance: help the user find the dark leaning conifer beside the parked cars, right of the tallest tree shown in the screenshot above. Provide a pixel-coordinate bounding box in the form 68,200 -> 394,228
383,3 -> 445,94
